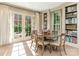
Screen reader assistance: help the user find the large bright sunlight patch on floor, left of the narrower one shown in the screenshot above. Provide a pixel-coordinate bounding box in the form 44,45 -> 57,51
11,43 -> 26,56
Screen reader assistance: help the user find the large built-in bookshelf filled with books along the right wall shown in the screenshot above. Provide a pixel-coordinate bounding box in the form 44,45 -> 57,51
65,4 -> 77,44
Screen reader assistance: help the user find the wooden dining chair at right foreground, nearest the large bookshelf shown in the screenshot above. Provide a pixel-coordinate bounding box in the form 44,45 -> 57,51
50,33 -> 67,56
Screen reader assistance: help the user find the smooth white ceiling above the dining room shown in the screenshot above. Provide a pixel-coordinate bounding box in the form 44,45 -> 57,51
7,2 -> 64,11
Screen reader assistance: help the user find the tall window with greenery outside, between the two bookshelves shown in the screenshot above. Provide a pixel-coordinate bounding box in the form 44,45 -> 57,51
51,10 -> 61,36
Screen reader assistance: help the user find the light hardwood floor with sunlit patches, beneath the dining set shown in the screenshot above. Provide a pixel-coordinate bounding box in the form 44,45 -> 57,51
0,41 -> 79,56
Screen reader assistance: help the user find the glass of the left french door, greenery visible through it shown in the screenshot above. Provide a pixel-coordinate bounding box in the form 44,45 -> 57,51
14,14 -> 22,38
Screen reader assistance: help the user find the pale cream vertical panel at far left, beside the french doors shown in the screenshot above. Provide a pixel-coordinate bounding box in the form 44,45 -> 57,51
0,5 -> 10,45
